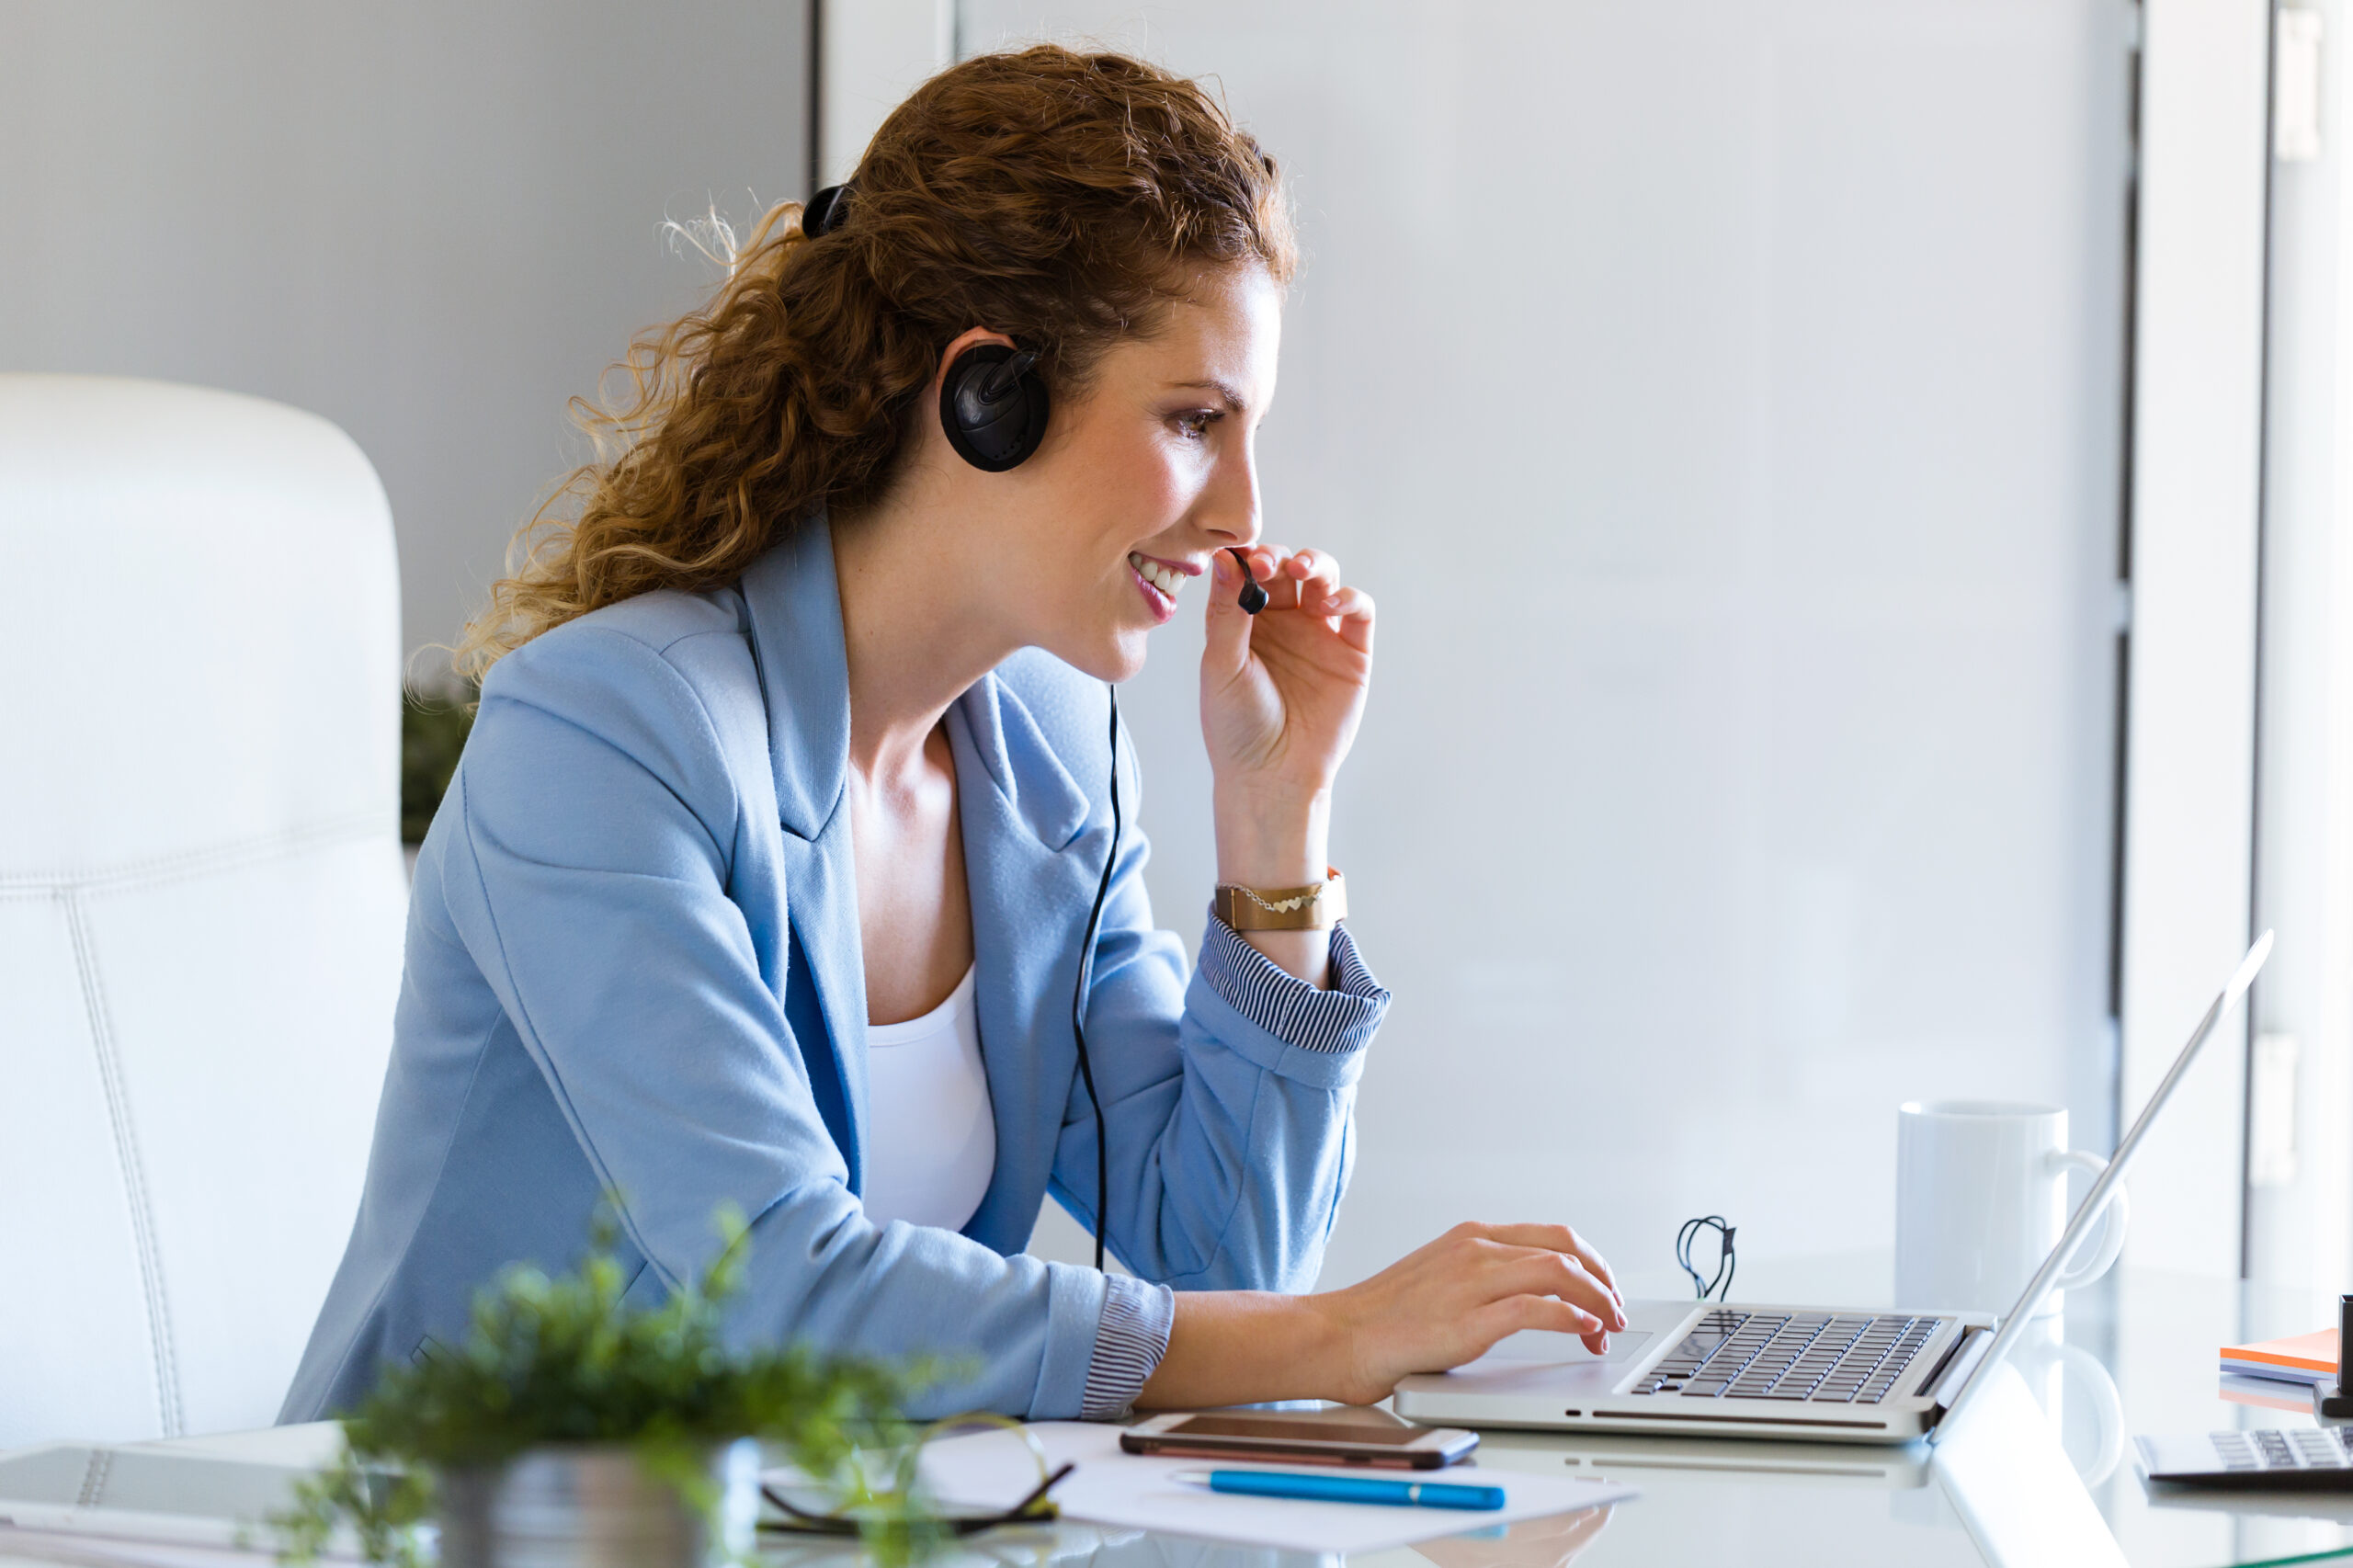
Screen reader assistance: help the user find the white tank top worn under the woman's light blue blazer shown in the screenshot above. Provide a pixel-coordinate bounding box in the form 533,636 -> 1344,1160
866,970 -> 997,1232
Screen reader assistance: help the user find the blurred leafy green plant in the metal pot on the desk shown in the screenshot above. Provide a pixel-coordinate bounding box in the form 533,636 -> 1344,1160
270,1210 -> 937,1568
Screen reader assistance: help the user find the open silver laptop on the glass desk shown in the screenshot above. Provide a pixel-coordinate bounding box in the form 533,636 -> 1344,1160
1393,930 -> 2270,1443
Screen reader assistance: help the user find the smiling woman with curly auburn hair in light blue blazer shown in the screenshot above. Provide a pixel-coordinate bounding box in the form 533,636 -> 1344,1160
285,47 -> 1623,1420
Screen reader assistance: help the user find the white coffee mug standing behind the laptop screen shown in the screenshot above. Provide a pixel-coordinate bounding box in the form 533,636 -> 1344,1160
1896,1099 -> 2127,1313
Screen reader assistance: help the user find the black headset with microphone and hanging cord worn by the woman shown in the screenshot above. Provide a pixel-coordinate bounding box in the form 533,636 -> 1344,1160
800,186 -> 1266,1269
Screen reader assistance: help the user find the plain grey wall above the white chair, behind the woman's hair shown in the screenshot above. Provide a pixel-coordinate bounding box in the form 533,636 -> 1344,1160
0,0 -> 810,671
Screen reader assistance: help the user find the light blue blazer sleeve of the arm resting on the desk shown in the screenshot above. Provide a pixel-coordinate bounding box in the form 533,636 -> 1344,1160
445,626 -> 1106,1420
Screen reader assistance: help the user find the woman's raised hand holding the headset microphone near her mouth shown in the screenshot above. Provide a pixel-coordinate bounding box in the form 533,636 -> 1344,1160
1200,544 -> 1371,819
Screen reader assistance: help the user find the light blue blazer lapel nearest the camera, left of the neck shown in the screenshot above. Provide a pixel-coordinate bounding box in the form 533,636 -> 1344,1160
741,516 -> 869,1191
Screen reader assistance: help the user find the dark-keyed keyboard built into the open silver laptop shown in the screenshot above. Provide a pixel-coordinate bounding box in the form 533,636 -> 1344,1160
1629,1307 -> 1941,1405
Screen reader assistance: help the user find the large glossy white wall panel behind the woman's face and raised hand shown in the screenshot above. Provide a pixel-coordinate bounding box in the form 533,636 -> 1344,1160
960,0 -> 2130,1283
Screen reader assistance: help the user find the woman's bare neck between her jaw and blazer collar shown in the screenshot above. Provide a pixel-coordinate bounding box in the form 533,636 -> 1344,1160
833,496 -> 1021,779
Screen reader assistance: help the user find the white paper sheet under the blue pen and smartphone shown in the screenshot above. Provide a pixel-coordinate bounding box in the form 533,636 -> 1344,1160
884,1422 -> 1635,1551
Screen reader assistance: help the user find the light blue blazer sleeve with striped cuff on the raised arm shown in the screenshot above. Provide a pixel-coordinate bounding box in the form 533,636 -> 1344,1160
1051,724 -> 1388,1290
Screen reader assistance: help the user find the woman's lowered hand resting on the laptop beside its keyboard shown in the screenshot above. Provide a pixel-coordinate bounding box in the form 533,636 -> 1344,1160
1306,1224 -> 1626,1405
